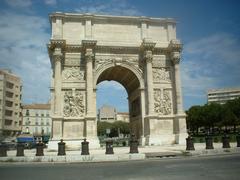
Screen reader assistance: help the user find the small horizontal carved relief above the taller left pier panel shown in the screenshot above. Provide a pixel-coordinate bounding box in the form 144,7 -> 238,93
63,67 -> 84,81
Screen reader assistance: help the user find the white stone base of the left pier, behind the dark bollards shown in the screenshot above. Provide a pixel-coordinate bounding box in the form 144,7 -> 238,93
48,138 -> 100,151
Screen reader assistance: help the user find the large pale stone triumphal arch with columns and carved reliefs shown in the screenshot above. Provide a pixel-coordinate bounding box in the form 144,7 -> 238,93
48,13 -> 186,148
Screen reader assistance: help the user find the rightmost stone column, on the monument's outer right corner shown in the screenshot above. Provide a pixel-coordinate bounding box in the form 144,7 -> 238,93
172,52 -> 183,114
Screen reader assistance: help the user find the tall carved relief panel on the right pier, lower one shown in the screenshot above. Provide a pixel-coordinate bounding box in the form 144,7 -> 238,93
154,89 -> 172,115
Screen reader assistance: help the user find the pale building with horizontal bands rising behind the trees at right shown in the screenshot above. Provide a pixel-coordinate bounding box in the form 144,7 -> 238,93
207,88 -> 240,104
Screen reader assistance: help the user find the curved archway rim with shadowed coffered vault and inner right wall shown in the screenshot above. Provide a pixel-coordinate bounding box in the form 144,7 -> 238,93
94,62 -> 145,139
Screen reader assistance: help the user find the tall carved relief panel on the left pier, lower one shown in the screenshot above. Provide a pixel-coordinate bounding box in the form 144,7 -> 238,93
63,90 -> 85,117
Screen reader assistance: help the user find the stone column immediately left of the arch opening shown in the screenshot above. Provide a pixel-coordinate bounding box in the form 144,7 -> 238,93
85,48 -> 94,117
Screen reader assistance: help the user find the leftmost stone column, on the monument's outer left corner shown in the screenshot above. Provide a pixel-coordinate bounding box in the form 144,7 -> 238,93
53,47 -> 63,116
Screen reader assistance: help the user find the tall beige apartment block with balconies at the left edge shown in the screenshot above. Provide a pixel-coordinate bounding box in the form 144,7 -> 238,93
0,70 -> 22,137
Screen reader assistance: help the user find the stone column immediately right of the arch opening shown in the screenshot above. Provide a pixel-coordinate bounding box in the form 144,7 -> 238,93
144,50 -> 154,115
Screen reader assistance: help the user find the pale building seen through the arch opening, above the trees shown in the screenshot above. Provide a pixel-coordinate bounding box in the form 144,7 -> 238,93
98,105 -> 129,123
